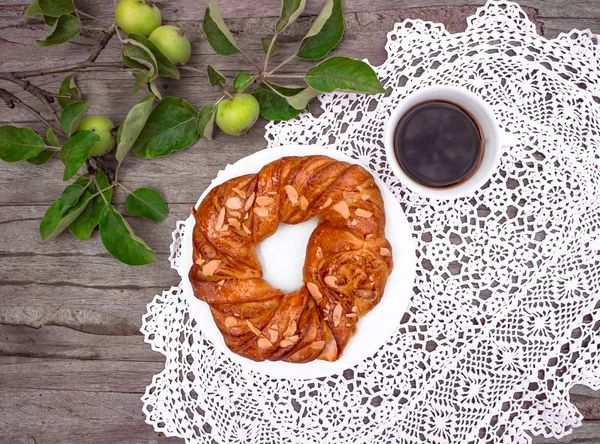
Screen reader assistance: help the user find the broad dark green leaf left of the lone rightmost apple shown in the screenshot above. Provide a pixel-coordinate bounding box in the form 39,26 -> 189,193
131,97 -> 198,158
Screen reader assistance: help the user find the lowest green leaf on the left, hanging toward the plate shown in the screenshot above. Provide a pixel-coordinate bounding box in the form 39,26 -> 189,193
100,205 -> 156,265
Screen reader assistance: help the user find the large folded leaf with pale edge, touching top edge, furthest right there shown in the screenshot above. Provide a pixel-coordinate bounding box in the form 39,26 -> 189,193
298,0 -> 344,60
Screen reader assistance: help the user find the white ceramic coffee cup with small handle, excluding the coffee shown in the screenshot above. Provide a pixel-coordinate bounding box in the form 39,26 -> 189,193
384,86 -> 514,199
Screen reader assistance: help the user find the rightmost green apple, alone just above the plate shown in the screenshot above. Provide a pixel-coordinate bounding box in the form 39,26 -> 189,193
215,93 -> 260,136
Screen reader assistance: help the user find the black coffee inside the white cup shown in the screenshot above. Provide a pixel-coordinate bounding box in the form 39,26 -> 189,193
394,100 -> 484,188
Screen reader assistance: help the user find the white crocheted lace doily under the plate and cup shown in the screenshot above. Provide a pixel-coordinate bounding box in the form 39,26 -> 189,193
142,2 -> 600,444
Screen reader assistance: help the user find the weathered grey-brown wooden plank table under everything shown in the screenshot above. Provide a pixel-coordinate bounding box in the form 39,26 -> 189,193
0,0 -> 600,444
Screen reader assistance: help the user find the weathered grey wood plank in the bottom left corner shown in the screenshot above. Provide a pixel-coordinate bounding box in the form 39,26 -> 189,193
0,386 -> 182,444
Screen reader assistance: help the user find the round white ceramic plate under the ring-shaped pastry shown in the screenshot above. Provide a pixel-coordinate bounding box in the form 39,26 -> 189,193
178,145 -> 416,379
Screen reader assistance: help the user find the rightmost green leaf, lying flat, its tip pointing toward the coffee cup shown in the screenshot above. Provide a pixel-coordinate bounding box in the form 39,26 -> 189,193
304,57 -> 386,94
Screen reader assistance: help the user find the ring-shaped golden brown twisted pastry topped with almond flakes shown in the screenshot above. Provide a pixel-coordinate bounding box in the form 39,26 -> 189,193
189,156 -> 392,362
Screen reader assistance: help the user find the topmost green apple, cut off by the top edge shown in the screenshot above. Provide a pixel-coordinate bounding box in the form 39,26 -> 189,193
115,0 -> 161,37
